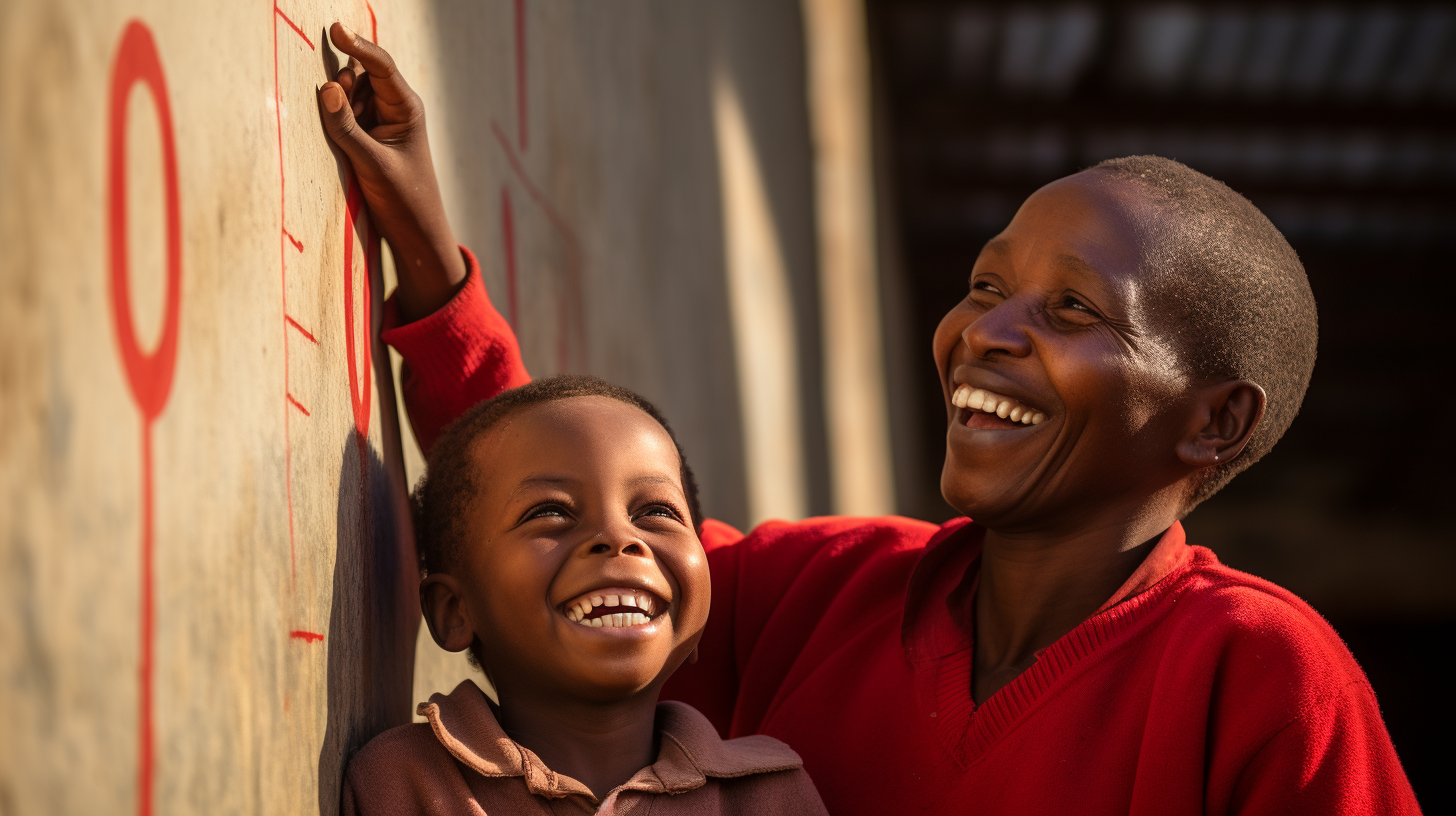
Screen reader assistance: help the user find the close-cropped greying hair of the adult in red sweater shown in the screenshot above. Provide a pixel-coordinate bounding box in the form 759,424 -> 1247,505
1088,156 -> 1319,513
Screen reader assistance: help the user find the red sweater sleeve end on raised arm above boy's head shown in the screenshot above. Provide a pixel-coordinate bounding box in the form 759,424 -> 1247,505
383,246 -> 531,453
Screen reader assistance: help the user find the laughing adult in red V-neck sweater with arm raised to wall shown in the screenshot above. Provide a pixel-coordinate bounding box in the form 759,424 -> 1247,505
322,23 -> 1418,815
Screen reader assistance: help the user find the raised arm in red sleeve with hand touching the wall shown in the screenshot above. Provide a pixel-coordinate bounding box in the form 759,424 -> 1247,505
319,23 -> 530,452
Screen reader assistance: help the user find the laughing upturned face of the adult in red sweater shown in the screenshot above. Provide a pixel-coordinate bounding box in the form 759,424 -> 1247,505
935,173 -> 1192,532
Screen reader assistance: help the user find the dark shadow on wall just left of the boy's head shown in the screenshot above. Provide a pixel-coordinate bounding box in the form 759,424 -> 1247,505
317,433 -> 415,816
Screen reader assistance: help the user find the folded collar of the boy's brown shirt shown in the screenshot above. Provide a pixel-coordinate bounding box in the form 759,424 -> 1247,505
418,680 -> 804,804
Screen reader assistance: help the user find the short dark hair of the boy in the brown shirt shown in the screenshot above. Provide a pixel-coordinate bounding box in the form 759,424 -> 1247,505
411,374 -> 703,576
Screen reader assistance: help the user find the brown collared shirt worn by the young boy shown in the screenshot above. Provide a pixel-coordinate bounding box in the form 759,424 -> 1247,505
334,680 -> 826,816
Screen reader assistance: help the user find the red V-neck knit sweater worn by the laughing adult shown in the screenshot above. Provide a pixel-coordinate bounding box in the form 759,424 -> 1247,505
384,252 -> 1420,816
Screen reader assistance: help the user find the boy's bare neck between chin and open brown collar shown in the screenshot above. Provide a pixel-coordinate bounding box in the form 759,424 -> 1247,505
495,689 -> 658,800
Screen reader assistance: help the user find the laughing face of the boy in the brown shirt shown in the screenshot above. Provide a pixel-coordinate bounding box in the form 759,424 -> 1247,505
425,396 -> 709,702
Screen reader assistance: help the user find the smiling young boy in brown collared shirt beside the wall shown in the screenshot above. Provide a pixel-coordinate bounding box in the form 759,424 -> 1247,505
334,377 -> 824,816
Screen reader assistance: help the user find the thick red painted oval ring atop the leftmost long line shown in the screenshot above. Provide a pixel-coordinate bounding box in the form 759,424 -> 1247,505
106,20 -> 182,423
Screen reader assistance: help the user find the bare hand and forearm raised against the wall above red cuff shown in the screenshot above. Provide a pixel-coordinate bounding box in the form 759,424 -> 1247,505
319,23 -> 466,322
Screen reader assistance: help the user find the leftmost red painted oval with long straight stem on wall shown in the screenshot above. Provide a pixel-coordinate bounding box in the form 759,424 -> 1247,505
106,20 -> 182,816
